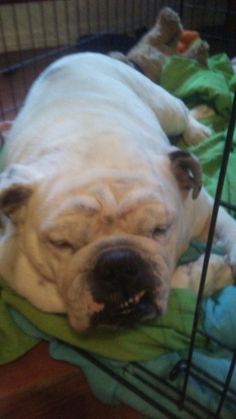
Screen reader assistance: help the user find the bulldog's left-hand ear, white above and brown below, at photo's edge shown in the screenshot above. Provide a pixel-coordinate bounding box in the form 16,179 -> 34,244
0,164 -> 35,223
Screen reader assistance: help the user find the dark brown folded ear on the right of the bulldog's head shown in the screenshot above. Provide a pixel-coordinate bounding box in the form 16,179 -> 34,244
169,150 -> 202,199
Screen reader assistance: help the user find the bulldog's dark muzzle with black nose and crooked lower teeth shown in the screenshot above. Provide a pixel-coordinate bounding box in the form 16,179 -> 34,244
91,248 -> 158,327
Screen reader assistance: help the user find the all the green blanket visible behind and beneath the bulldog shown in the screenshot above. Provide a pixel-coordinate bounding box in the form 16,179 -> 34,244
0,55 -> 236,363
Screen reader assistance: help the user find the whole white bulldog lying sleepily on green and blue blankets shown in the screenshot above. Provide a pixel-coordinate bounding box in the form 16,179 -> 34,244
0,53 -> 236,332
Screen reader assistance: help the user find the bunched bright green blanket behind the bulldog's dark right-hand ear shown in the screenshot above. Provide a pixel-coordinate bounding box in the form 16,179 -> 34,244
161,54 -> 236,202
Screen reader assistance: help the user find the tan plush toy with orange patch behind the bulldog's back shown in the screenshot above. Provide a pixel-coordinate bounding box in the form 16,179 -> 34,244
110,7 -> 209,82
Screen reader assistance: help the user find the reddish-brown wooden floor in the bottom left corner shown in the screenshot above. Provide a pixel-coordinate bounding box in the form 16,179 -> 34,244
0,343 -> 142,419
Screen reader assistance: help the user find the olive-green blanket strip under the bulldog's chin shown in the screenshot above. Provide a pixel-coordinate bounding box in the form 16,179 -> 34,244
0,276 -> 204,362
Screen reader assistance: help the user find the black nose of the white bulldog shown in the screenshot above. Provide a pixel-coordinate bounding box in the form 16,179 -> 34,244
93,248 -> 147,298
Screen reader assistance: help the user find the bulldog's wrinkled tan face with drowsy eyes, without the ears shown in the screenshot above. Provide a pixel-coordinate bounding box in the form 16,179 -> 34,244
33,172 -> 179,331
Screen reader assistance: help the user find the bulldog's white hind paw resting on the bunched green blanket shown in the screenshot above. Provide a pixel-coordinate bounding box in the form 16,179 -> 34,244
183,115 -> 212,144
